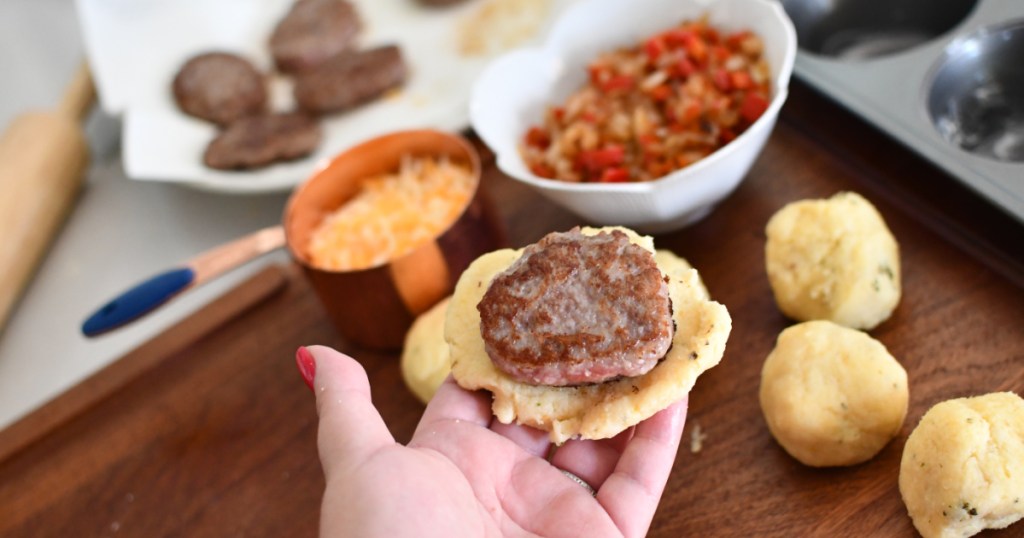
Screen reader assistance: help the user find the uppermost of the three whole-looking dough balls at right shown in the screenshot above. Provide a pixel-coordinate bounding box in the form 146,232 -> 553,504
765,193 -> 900,330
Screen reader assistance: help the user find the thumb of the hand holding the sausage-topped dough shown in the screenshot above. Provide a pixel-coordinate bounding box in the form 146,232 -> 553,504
298,345 -> 394,475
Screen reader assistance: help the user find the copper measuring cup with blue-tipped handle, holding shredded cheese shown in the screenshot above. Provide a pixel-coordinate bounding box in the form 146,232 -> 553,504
82,129 -> 505,349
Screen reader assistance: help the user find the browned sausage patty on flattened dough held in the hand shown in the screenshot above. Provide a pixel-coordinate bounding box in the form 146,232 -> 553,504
477,229 -> 674,386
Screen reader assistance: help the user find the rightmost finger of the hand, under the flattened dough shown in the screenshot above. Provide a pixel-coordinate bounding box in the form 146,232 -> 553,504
597,399 -> 687,536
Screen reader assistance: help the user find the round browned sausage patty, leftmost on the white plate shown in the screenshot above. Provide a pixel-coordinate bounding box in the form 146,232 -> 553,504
172,52 -> 266,125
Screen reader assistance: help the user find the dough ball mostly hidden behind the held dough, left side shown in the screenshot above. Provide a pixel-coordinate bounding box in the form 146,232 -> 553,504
401,297 -> 452,404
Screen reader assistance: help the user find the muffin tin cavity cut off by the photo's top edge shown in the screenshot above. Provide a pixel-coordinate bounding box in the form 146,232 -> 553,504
782,0 -> 977,60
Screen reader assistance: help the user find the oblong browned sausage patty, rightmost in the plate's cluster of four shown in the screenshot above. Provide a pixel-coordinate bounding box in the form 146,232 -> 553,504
295,45 -> 408,114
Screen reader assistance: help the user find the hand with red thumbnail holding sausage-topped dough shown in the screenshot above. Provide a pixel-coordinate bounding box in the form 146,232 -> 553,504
296,346 -> 686,537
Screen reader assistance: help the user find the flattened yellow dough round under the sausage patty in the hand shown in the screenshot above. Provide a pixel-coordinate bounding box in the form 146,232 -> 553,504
444,227 -> 732,445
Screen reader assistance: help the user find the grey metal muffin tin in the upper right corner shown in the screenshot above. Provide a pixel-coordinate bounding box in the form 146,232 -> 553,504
781,0 -> 1024,221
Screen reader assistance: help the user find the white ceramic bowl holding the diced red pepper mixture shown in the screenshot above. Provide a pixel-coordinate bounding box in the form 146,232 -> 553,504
470,0 -> 797,234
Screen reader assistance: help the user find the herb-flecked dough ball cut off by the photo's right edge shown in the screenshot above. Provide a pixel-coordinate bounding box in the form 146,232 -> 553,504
899,392 -> 1024,538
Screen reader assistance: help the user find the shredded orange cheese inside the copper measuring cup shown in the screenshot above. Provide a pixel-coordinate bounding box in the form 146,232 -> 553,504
309,158 -> 473,271
